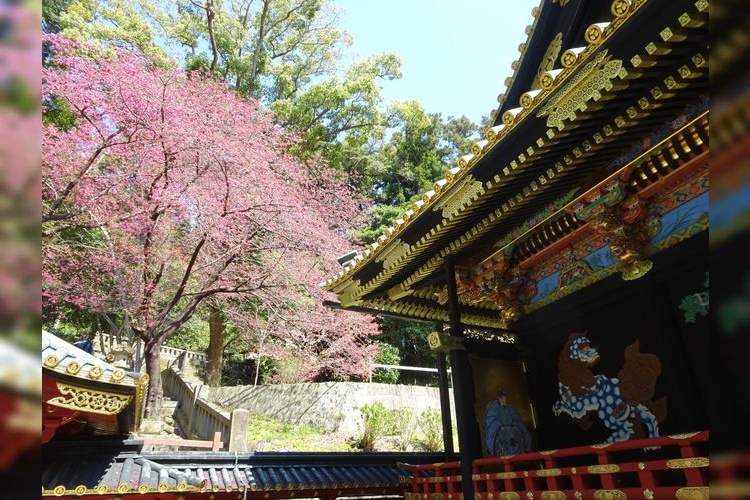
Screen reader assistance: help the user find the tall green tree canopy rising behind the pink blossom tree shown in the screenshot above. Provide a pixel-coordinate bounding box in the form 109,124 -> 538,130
44,0 -> 478,380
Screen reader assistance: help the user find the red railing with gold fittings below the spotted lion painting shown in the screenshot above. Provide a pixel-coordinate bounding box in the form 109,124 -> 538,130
406,431 -> 709,500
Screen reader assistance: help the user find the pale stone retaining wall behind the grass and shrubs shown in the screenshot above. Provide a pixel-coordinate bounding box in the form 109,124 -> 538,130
202,382 -> 455,435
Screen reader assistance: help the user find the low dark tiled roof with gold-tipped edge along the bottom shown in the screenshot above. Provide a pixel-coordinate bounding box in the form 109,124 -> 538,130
42,440 -> 444,498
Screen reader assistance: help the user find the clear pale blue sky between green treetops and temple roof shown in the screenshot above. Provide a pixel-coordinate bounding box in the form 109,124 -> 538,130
334,0 -> 539,125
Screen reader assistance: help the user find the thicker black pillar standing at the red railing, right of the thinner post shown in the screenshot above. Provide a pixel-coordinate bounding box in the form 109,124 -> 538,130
445,259 -> 482,500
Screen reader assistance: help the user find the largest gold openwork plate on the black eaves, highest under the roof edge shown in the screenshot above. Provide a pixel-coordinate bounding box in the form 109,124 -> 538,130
537,50 -> 622,130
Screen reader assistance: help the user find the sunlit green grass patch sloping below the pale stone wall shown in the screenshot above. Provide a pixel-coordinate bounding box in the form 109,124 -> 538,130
247,413 -> 351,451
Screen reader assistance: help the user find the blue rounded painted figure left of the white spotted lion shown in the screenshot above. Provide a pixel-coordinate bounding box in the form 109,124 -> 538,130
485,389 -> 531,456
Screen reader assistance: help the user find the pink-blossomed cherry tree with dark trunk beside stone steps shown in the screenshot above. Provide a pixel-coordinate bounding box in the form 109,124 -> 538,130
42,36 -> 377,415
